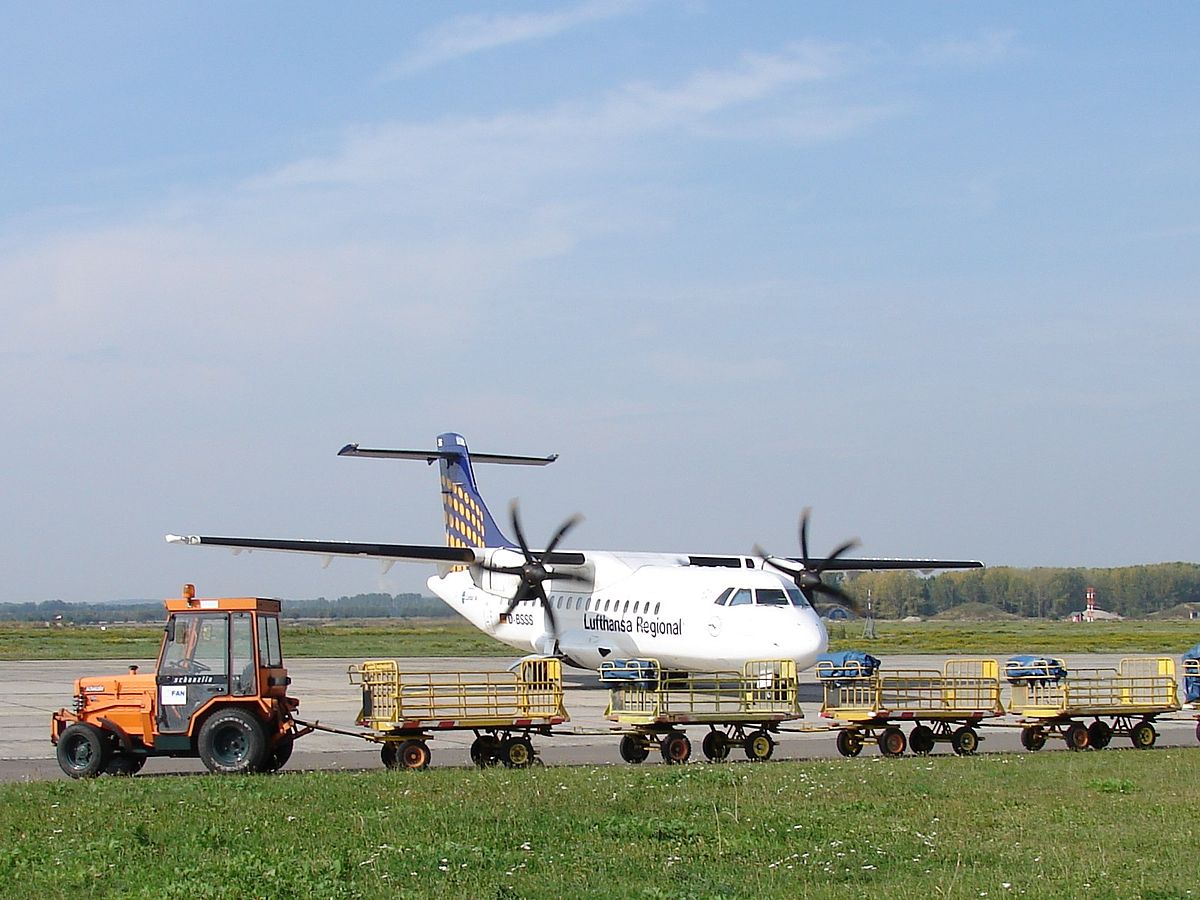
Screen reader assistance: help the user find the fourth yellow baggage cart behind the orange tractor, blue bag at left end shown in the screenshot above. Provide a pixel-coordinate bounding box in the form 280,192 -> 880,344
1009,656 -> 1180,750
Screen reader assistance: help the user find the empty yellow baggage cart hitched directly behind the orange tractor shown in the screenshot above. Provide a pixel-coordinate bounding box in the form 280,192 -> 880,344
348,658 -> 570,769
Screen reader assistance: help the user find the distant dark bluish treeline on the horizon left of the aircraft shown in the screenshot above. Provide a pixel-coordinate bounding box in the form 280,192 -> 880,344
0,594 -> 454,625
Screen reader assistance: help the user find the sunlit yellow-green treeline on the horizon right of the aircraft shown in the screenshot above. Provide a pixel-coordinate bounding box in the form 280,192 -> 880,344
842,563 -> 1200,619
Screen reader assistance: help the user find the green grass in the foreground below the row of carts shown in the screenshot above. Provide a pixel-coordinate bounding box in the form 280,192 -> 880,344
0,749 -> 1200,898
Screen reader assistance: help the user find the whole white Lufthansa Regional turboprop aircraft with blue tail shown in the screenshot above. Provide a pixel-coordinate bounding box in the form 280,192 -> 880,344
167,432 -> 983,672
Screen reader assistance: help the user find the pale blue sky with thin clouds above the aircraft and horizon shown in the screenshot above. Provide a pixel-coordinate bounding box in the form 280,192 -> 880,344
0,0 -> 1200,602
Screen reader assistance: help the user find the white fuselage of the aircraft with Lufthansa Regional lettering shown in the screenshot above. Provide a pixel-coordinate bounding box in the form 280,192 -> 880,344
428,550 -> 828,672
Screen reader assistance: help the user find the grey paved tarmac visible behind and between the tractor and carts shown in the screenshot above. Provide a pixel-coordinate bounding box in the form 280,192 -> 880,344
0,654 -> 1200,781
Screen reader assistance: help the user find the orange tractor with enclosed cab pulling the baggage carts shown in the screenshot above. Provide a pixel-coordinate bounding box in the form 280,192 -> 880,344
50,584 -> 308,778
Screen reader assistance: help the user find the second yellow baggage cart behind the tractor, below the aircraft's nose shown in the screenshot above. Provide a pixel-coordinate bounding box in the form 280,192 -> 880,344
600,660 -> 804,764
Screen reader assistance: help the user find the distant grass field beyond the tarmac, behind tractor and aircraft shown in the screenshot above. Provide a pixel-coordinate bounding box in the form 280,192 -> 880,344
0,618 -> 1200,660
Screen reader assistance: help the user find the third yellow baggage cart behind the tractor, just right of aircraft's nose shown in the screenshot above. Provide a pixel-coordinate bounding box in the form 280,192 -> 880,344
816,659 -> 1004,756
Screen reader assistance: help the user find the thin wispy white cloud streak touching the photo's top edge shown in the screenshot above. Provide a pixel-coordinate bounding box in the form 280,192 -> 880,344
382,0 -> 644,80
